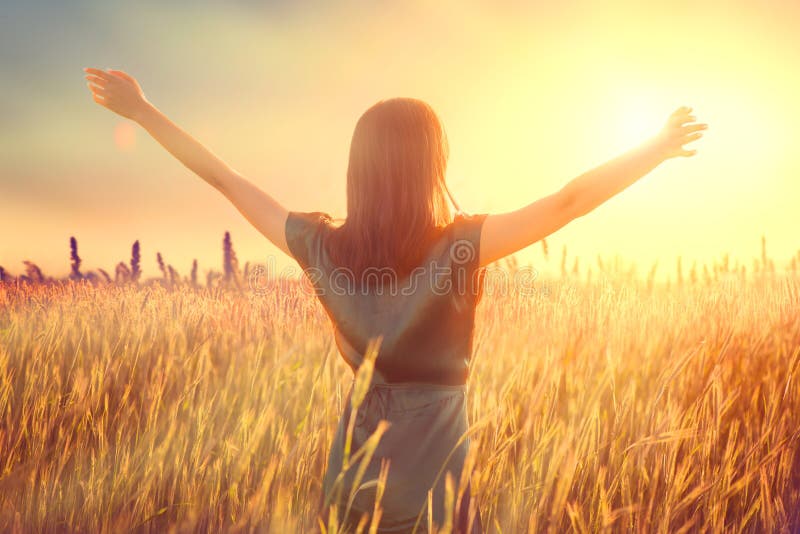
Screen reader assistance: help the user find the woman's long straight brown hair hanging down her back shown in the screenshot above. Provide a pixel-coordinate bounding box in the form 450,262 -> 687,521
327,98 -> 452,280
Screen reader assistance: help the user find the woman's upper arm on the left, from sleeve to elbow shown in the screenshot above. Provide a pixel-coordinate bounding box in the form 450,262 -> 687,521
219,172 -> 291,255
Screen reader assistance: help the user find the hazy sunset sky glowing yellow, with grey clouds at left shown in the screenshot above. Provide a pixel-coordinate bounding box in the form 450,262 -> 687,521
0,0 -> 800,277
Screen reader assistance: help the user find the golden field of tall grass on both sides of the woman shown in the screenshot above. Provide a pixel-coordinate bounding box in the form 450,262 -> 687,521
0,258 -> 800,532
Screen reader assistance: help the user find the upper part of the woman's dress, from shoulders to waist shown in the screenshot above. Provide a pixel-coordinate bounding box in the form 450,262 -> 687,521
285,212 -> 486,385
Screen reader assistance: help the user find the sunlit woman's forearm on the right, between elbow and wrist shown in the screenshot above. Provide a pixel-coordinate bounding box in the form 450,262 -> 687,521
561,140 -> 665,220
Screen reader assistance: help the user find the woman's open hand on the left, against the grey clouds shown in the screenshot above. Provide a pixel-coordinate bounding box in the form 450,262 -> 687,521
83,67 -> 150,121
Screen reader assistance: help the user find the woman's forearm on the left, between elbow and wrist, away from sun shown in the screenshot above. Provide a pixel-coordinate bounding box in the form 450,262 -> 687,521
135,102 -> 234,191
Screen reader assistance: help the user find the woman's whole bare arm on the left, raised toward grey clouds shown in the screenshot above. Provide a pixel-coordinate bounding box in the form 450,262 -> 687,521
84,68 -> 290,254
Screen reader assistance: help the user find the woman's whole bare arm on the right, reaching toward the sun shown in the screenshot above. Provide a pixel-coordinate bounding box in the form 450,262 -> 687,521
479,107 -> 708,266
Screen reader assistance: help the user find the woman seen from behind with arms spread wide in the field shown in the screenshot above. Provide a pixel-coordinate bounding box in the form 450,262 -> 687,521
84,68 -> 706,532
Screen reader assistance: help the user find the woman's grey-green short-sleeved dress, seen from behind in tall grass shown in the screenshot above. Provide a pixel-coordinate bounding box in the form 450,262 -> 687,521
286,212 -> 486,533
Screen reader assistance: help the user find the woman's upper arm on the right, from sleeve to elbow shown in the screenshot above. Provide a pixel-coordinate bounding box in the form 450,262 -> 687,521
480,190 -> 580,266
